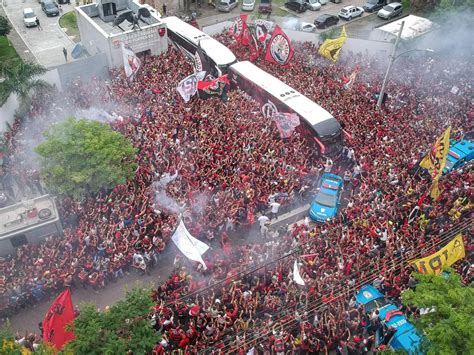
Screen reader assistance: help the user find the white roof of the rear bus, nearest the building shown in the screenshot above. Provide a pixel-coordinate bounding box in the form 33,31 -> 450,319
161,16 -> 237,65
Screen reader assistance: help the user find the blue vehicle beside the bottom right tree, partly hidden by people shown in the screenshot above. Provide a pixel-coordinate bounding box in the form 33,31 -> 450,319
356,285 -> 422,354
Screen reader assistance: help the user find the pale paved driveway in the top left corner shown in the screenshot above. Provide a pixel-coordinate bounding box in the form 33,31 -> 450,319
0,0 -> 74,68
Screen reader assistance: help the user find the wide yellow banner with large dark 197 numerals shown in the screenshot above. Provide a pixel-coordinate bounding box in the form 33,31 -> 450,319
413,234 -> 466,274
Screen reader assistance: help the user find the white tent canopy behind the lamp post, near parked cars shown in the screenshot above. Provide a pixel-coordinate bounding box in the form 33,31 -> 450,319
371,15 -> 433,40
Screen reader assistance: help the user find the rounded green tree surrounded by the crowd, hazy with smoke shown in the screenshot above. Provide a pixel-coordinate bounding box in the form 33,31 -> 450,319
35,118 -> 136,197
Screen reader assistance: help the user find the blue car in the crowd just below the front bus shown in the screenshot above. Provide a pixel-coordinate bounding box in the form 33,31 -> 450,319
309,173 -> 344,223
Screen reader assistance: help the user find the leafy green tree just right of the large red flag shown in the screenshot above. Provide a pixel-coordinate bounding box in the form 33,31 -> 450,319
64,288 -> 160,355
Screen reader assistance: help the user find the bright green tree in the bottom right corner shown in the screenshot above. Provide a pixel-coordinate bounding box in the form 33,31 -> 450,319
402,269 -> 474,354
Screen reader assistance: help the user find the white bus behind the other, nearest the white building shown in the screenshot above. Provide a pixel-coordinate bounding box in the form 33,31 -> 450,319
161,16 -> 237,77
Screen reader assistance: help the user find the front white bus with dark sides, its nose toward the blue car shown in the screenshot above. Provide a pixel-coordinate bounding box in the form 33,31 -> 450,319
228,61 -> 343,157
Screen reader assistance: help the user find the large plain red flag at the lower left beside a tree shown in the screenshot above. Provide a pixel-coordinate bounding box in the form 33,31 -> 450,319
43,289 -> 74,350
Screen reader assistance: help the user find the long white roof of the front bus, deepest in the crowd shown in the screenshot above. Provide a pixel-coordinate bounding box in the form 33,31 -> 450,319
232,61 -> 339,129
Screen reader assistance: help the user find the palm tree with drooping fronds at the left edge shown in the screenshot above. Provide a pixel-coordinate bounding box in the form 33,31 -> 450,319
2,62 -> 52,113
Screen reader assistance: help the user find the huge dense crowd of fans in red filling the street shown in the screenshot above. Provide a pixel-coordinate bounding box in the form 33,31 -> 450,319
0,29 -> 474,354
